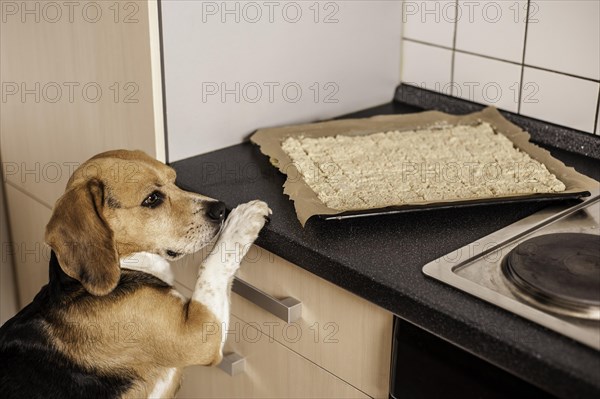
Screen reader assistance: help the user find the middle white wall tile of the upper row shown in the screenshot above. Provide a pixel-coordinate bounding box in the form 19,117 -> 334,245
456,0 -> 527,62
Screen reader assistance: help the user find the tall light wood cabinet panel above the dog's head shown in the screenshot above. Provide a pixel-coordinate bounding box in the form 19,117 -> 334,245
0,0 -> 159,206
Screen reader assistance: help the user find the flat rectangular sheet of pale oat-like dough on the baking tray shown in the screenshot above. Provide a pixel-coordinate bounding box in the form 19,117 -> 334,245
281,123 -> 565,211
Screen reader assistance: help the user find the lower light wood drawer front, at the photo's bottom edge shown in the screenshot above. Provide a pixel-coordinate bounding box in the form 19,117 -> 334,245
177,316 -> 368,399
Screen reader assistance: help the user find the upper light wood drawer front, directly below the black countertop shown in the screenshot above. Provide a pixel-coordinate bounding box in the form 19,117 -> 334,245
231,246 -> 393,398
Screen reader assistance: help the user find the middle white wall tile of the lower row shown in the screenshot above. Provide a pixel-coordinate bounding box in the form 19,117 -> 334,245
453,53 -> 521,112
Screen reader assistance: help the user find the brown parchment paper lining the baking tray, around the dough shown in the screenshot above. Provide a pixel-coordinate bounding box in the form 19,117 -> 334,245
250,107 -> 600,226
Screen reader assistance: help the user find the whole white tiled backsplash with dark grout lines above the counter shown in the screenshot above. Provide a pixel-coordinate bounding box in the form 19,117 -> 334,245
401,0 -> 600,134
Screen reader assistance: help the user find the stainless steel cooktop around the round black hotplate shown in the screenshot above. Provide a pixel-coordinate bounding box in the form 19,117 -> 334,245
423,191 -> 600,350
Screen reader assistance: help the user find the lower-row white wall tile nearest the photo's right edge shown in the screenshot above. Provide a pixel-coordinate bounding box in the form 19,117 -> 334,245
521,67 -> 600,133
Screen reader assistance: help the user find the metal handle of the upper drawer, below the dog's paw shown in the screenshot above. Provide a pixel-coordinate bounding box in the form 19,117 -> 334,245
231,277 -> 302,323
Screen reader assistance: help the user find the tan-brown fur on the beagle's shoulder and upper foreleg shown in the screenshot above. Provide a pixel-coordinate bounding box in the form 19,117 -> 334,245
47,287 -> 221,398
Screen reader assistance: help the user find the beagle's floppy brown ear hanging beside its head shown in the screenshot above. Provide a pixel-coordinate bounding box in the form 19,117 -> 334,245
46,179 -> 121,295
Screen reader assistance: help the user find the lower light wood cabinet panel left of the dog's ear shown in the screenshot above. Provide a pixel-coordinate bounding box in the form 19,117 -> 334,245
2,184 -> 51,307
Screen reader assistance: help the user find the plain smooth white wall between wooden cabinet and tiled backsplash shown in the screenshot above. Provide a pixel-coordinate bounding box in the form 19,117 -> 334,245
162,0 -> 401,161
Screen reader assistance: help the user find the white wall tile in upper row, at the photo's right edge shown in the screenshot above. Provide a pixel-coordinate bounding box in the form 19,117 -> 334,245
525,0 -> 600,79
